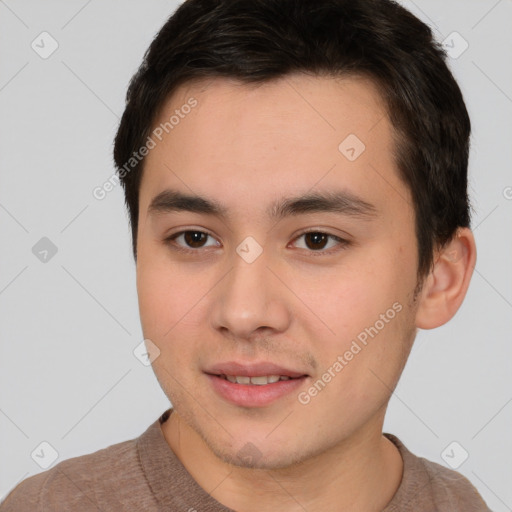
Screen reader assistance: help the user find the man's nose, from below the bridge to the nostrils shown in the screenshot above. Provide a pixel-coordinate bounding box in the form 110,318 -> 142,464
211,246 -> 291,340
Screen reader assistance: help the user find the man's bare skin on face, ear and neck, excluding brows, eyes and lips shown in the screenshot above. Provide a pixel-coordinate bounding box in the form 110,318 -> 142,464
137,74 -> 476,512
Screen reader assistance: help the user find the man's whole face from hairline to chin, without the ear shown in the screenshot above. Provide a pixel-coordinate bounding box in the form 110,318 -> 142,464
137,75 -> 418,468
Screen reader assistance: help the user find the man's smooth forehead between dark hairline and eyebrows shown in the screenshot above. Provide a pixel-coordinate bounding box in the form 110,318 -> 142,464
141,74 -> 408,222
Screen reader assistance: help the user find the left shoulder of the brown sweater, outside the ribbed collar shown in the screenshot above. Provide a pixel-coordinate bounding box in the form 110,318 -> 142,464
0,439 -> 151,512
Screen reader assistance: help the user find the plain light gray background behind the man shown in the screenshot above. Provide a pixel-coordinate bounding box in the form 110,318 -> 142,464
0,0 -> 512,512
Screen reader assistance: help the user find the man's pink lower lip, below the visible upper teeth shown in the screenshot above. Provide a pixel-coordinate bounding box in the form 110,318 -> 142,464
206,374 -> 307,407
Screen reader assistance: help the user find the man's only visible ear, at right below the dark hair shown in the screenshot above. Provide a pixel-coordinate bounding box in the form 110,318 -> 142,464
416,228 -> 476,329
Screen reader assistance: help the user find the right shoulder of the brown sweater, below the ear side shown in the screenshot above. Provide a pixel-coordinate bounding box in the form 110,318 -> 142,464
385,434 -> 491,512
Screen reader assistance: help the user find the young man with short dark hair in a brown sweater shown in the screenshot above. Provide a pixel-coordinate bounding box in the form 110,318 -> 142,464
0,0 -> 489,512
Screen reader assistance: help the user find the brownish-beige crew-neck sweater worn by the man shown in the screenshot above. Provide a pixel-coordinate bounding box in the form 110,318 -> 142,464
0,409 -> 490,512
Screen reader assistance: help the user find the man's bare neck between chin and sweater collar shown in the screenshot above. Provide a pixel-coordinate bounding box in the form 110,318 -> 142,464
162,411 -> 403,512
